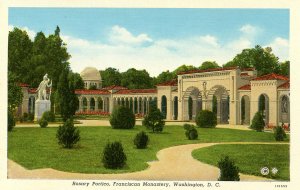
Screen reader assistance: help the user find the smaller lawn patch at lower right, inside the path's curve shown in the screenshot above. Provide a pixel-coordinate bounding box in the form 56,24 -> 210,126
192,144 -> 290,180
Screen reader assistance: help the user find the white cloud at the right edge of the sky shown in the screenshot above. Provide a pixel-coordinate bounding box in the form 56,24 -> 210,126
265,37 -> 289,61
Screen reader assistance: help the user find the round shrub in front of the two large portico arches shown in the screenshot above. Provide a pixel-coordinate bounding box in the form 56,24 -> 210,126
196,110 -> 217,128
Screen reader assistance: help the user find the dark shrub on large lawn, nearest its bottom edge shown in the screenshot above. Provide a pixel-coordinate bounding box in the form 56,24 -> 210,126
102,142 -> 127,169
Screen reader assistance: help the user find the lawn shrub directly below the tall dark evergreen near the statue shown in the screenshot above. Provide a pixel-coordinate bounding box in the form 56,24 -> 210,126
56,119 -> 80,148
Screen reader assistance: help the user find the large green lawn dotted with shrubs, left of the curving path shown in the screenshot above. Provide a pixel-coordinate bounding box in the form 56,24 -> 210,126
8,126 -> 288,173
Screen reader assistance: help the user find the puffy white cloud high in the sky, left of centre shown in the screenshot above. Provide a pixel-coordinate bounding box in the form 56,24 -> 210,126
109,25 -> 152,45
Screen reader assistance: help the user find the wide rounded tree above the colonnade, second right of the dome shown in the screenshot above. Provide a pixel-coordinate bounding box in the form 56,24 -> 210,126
121,68 -> 153,89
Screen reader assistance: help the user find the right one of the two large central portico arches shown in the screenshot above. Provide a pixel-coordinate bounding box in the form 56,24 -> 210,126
206,85 -> 230,124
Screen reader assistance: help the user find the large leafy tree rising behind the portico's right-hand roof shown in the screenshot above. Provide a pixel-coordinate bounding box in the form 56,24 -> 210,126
224,45 -> 279,76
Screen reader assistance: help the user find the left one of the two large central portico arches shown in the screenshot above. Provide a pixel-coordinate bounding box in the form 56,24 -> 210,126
183,86 -> 202,120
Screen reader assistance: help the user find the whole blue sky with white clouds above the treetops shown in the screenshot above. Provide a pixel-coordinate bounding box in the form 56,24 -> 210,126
9,8 -> 289,76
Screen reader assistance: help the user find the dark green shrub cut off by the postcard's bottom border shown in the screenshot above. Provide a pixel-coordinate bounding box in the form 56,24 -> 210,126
218,156 -> 240,181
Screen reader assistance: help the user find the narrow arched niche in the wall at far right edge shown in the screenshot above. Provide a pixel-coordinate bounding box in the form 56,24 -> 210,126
279,95 -> 290,123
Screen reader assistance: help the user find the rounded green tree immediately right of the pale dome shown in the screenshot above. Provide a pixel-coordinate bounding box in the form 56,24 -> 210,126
100,67 -> 121,87
